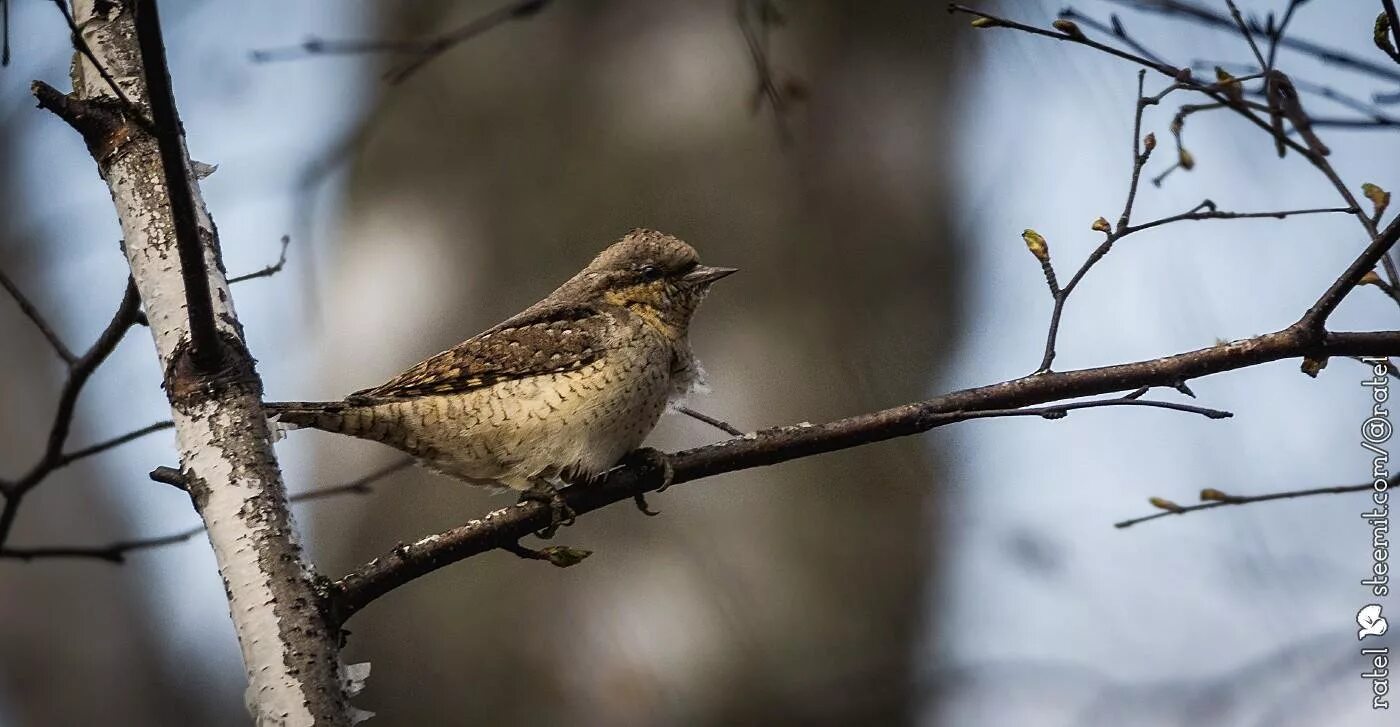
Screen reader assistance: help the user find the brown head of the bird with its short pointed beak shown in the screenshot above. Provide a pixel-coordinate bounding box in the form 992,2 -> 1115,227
570,230 -> 736,336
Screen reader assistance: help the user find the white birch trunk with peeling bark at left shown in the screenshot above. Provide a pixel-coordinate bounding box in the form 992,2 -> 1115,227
35,0 -> 349,726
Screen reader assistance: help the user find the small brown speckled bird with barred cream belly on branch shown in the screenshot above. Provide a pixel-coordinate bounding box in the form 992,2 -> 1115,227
266,228 -> 736,536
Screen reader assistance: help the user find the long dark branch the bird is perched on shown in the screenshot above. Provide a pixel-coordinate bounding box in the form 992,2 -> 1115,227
332,329 -> 1400,622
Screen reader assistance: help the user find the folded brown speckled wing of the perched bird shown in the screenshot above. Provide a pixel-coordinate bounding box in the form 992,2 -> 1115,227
347,305 -> 609,402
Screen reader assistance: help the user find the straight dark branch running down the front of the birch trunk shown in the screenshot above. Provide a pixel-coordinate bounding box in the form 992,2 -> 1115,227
133,0 -> 224,373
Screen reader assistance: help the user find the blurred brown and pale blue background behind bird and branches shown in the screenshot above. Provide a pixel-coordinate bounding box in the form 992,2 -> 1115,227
0,0 -> 1400,726
